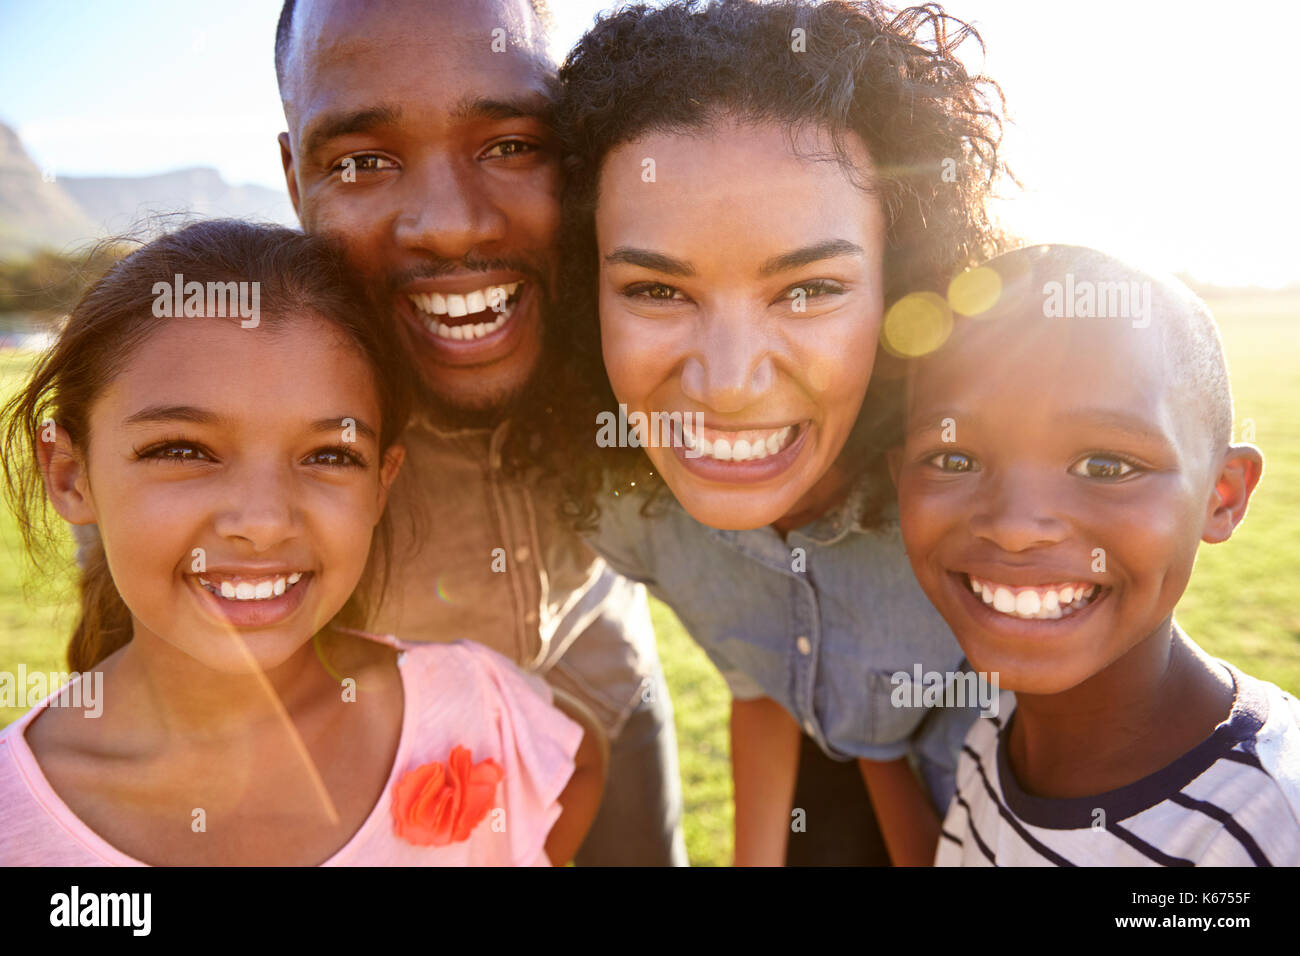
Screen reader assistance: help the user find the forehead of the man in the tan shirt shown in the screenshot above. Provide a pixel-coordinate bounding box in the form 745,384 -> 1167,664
285,0 -> 554,129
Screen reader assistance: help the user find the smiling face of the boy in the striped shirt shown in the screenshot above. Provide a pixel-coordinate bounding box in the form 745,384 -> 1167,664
896,300 -> 1222,693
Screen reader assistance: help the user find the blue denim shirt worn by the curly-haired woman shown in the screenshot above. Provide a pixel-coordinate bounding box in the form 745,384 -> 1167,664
590,483 -> 978,809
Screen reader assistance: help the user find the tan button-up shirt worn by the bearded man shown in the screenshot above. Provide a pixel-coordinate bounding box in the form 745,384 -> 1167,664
371,415 -> 659,740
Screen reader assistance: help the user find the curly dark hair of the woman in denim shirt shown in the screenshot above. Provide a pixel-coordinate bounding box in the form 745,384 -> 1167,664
547,0 -> 1010,528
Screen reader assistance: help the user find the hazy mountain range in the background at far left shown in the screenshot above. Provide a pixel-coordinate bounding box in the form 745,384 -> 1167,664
0,124 -> 298,259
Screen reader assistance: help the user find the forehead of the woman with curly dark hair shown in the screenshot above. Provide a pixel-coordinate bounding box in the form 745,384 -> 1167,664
597,121 -> 883,258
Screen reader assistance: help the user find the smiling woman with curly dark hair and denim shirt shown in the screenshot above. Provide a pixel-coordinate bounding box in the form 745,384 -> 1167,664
556,0 -> 1001,864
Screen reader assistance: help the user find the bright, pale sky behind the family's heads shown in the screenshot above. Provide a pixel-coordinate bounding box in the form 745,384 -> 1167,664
0,0 -> 1300,285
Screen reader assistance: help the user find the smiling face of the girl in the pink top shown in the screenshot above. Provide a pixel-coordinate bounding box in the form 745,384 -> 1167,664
65,315 -> 402,672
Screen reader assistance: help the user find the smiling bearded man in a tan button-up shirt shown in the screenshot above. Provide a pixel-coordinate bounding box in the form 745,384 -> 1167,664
276,0 -> 685,865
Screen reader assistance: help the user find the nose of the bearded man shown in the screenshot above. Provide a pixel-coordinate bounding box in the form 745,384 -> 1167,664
394,156 -> 507,260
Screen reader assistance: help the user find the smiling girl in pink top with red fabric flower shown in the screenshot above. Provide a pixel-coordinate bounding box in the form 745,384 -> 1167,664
0,221 -> 602,865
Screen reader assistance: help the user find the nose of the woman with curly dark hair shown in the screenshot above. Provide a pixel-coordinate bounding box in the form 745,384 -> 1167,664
681,306 -> 776,414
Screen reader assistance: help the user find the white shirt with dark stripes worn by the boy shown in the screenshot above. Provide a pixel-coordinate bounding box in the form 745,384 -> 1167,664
935,662 -> 1300,866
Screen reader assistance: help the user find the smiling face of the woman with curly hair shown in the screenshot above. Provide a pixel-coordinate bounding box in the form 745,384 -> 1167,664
595,122 -> 885,528
